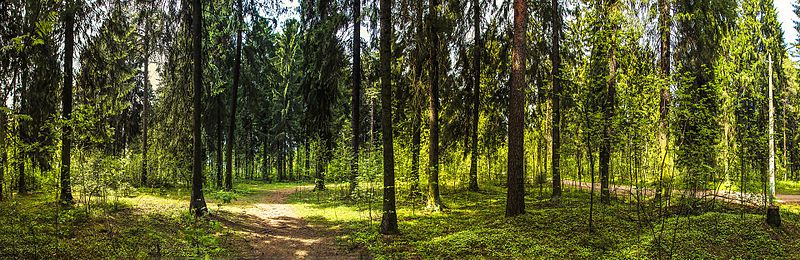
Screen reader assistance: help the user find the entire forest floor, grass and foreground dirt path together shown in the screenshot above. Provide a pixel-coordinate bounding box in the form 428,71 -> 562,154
0,181 -> 800,259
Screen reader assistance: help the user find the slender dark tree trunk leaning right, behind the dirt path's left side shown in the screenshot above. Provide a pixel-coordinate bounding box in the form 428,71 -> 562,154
225,0 -> 242,191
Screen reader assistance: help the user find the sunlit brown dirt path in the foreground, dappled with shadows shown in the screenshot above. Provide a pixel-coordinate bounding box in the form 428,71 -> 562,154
214,187 -> 368,259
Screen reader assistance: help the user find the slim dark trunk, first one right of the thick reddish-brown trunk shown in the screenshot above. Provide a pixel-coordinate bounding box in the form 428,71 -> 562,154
550,0 -> 561,201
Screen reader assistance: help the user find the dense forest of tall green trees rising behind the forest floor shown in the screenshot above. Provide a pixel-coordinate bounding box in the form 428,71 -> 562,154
0,0 -> 800,256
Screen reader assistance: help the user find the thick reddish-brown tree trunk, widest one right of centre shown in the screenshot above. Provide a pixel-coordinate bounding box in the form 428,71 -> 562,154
506,0 -> 528,217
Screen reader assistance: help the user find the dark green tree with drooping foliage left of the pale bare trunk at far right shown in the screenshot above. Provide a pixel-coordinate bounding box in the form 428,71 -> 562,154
673,0 -> 736,196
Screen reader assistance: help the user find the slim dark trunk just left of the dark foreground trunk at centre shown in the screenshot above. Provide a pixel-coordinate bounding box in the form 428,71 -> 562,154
348,0 -> 361,196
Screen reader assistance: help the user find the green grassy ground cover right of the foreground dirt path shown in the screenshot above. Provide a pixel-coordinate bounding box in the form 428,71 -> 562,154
291,183 -> 800,259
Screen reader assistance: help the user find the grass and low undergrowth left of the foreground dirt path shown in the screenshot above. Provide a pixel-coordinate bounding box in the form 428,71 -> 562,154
0,181 -> 306,259
